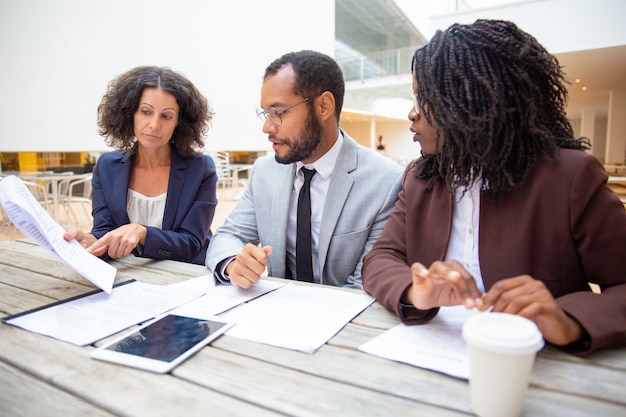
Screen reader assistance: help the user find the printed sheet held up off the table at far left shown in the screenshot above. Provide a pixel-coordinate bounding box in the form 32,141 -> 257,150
0,175 -> 117,293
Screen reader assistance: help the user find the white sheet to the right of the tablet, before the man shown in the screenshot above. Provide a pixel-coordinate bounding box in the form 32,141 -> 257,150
220,284 -> 374,353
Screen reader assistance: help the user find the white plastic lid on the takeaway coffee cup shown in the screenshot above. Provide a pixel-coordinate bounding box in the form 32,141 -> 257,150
463,313 -> 544,355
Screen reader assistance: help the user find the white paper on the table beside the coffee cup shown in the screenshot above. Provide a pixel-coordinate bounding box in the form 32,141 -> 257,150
359,306 -> 478,379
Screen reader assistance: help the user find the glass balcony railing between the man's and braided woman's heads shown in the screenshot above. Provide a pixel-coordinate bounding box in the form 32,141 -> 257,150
338,46 -> 419,81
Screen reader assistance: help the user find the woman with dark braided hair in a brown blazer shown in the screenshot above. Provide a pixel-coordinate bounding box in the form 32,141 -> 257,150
362,20 -> 626,354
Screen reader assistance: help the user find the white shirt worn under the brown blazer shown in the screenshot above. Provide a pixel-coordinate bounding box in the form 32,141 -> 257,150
445,180 -> 485,292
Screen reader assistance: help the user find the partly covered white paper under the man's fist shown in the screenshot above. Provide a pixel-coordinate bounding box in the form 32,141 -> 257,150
172,274 -> 285,317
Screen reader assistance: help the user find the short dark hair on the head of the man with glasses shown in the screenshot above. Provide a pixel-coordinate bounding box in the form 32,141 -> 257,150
263,50 -> 346,121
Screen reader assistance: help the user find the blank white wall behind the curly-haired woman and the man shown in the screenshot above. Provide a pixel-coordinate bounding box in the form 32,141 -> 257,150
0,0 -> 335,151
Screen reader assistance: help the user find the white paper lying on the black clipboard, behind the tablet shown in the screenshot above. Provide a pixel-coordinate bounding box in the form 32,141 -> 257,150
3,281 -> 202,346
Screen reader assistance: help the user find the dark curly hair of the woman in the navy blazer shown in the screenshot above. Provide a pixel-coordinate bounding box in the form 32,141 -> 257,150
98,66 -> 213,156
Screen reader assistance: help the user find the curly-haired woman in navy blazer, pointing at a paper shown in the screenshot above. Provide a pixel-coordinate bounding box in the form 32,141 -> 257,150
65,66 -> 217,264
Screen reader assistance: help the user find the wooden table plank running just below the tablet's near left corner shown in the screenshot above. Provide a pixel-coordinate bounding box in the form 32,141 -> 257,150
0,325 -> 277,417
